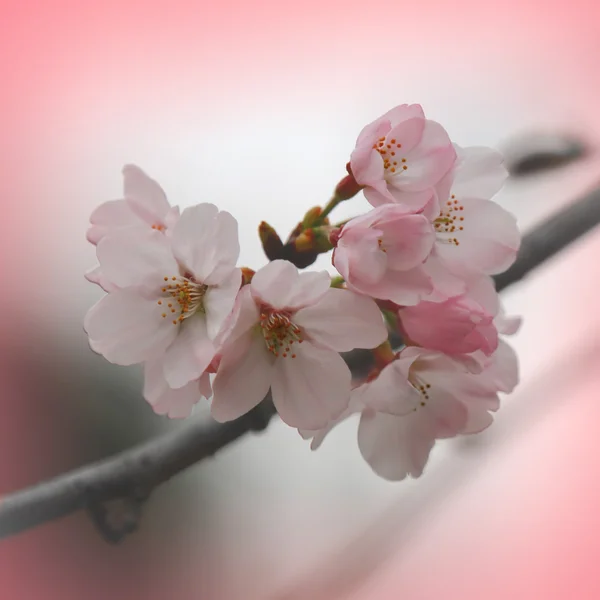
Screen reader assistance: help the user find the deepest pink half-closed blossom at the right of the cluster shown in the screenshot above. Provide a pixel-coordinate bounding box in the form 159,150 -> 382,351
398,276 -> 498,356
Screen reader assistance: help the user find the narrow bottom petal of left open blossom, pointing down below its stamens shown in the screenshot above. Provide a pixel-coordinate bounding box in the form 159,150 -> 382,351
163,314 -> 215,389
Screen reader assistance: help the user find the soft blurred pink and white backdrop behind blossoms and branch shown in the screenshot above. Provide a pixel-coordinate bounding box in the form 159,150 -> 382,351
0,0 -> 600,600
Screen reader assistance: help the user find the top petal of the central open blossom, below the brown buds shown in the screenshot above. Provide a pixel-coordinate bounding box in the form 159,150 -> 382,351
250,260 -> 331,310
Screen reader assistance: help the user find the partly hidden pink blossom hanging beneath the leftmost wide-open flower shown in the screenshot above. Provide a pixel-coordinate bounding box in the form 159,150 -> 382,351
144,360 -> 212,419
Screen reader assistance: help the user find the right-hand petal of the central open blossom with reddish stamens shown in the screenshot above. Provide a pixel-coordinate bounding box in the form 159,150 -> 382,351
293,289 -> 387,352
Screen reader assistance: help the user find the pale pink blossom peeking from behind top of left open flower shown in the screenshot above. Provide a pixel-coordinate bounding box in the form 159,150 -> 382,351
87,165 -> 179,244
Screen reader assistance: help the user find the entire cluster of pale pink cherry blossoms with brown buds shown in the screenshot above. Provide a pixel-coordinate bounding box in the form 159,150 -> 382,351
85,105 -> 520,480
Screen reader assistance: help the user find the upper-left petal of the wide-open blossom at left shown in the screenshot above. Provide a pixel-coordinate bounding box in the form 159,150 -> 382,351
96,229 -> 179,287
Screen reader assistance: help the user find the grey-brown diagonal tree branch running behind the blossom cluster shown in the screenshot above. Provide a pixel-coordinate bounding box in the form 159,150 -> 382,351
0,188 -> 600,541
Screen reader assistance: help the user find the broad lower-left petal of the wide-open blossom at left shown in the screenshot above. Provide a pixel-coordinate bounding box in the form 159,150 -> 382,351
84,288 -> 177,365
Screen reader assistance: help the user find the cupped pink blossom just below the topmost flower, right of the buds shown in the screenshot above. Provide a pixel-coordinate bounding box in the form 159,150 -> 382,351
333,204 -> 435,305
